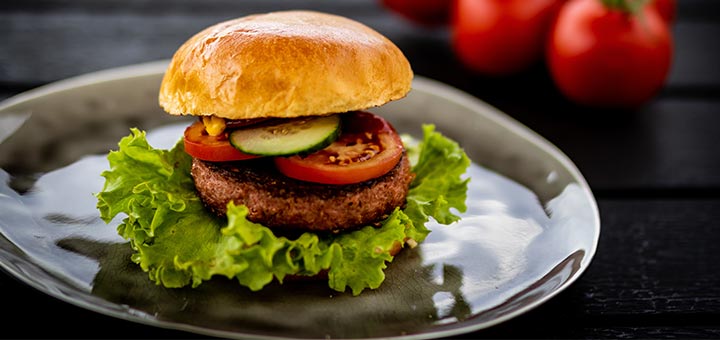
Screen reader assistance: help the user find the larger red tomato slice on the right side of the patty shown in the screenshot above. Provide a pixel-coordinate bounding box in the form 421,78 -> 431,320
275,112 -> 403,184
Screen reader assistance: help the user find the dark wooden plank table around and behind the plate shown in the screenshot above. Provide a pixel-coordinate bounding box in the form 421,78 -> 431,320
0,0 -> 720,338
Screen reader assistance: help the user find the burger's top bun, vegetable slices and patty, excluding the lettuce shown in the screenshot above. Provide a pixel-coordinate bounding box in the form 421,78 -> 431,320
159,11 -> 413,232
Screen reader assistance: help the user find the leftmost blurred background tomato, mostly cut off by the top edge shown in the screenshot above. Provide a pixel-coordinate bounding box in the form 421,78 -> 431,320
382,0 -> 451,26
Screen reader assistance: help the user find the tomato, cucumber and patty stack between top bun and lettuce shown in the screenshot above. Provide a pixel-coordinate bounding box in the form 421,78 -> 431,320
184,112 -> 414,232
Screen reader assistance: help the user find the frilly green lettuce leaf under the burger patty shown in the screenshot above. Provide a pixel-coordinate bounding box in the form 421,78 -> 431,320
96,125 -> 470,295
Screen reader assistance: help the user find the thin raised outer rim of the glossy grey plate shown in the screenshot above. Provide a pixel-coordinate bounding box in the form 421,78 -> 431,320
0,59 -> 601,340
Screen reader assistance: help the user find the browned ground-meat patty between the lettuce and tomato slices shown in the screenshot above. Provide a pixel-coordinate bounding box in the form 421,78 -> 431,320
191,156 -> 415,231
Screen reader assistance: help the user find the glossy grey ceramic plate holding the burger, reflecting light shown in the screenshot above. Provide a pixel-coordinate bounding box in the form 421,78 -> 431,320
0,62 -> 600,339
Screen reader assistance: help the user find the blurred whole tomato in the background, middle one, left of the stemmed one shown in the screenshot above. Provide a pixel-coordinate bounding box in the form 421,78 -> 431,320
451,0 -> 563,76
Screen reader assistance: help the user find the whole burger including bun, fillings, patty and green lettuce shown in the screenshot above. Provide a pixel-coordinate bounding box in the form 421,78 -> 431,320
97,11 -> 469,294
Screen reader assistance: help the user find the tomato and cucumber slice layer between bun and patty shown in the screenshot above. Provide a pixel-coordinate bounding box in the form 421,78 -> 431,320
184,111 -> 404,185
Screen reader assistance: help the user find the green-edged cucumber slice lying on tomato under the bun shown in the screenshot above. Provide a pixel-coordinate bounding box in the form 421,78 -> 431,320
229,115 -> 340,156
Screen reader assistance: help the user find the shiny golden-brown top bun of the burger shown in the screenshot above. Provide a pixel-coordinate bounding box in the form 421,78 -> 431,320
159,11 -> 413,119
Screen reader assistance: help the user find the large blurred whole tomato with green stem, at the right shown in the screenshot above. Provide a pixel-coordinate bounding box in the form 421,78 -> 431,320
547,0 -> 672,108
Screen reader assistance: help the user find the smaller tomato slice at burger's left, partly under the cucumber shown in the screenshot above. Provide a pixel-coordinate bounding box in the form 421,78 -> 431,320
183,121 -> 258,162
